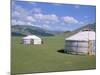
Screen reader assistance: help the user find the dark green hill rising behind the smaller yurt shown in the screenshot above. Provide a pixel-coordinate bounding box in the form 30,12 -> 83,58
11,25 -> 53,36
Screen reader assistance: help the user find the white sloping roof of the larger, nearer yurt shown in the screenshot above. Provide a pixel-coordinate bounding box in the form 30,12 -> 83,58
65,31 -> 95,41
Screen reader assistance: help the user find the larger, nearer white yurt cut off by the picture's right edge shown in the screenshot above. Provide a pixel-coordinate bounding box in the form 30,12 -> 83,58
64,30 -> 96,55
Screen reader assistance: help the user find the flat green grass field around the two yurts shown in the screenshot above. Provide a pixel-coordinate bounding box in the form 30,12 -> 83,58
11,36 -> 96,74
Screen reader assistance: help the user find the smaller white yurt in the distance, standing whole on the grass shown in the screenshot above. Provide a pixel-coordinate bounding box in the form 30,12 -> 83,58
22,35 -> 42,45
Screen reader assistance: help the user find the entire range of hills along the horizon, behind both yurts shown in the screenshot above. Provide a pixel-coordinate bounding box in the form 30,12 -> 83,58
11,23 -> 96,36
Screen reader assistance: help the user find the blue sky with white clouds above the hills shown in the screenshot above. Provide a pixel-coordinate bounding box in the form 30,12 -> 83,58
11,0 -> 96,31
